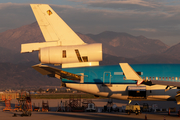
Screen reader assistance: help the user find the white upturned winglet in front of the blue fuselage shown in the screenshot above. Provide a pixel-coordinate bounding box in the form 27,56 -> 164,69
119,63 -> 143,86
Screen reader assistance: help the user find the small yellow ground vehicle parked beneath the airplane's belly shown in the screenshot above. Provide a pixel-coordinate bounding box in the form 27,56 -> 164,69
125,105 -> 141,115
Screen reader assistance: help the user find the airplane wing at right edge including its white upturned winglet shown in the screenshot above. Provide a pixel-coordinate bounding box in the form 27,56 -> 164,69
119,63 -> 180,87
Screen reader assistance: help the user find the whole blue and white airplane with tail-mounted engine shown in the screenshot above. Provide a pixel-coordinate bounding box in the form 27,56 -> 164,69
21,4 -> 180,104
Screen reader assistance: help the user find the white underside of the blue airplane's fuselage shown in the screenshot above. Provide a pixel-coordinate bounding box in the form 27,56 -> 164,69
65,83 -> 178,101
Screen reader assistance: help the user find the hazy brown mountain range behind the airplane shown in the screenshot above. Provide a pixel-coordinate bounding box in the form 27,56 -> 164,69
0,22 -> 180,89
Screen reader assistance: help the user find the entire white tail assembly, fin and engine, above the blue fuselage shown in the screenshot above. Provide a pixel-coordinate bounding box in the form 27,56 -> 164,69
21,4 -> 102,68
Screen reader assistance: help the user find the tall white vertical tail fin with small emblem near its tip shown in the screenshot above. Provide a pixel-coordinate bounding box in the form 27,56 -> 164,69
30,4 -> 84,45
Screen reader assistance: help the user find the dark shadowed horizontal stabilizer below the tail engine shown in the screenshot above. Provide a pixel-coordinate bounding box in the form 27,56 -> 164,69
32,64 -> 81,80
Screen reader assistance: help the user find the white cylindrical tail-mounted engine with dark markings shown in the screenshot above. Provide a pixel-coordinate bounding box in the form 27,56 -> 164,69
39,43 -> 102,64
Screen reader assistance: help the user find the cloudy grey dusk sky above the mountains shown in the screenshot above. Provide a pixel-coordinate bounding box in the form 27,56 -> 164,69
0,0 -> 180,46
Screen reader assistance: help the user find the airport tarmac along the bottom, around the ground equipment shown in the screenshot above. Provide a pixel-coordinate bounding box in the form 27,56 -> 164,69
0,99 -> 180,120
